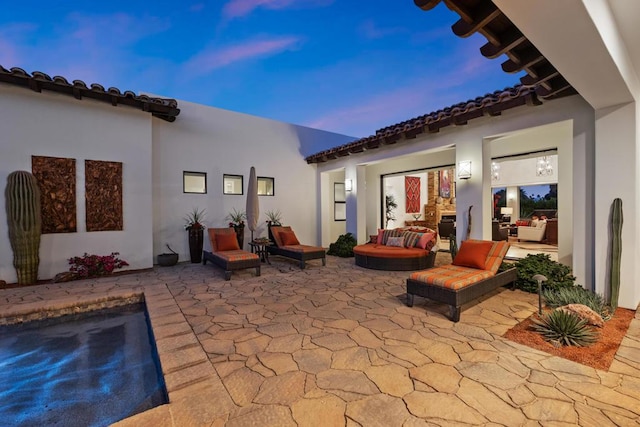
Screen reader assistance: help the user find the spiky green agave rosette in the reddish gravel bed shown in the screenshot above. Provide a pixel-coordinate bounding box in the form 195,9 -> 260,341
533,310 -> 598,347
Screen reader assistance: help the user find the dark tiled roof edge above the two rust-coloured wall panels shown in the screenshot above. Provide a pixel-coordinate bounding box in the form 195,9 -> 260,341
0,65 -> 180,122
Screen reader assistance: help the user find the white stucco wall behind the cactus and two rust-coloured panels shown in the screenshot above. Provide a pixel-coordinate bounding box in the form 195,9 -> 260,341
0,84 -> 153,283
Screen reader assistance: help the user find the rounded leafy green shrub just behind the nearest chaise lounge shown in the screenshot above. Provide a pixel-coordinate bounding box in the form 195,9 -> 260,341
515,254 -> 576,293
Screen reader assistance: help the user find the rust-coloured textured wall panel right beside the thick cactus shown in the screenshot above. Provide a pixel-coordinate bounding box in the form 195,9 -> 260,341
31,156 -> 77,234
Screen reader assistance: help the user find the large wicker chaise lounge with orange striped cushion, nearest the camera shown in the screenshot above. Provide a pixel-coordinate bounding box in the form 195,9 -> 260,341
407,240 -> 517,322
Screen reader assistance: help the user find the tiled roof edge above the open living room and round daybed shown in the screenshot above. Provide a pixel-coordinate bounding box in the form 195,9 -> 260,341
305,85 -> 542,163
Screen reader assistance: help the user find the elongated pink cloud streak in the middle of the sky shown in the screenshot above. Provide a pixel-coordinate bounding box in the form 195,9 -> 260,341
186,37 -> 300,74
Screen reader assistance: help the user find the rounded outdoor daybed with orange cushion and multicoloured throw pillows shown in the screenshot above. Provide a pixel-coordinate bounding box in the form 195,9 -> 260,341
353,228 -> 437,270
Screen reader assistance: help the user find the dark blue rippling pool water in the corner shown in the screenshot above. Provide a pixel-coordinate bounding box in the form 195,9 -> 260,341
0,303 -> 168,427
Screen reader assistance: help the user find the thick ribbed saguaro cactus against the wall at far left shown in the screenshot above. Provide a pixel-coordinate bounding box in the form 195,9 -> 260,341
4,171 -> 42,285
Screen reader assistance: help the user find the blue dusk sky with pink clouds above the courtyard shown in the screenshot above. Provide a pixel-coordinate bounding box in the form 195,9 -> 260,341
0,0 -> 520,137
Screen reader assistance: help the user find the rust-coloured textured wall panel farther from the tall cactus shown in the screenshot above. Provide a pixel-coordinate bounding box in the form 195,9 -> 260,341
84,160 -> 123,231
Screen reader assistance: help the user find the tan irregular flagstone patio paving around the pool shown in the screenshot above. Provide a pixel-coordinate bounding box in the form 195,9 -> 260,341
0,254 -> 640,427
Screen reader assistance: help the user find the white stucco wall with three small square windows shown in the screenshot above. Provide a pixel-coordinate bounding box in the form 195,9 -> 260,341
153,101 -> 352,261
